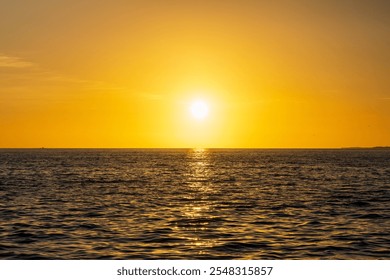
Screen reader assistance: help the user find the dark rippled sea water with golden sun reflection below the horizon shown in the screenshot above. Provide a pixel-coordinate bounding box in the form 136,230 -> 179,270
0,149 -> 390,259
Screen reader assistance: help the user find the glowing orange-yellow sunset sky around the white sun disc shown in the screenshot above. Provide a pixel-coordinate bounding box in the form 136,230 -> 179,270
0,0 -> 390,148
